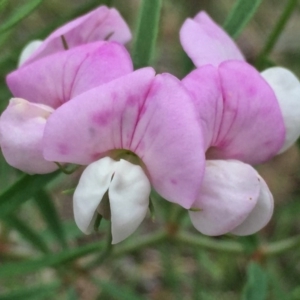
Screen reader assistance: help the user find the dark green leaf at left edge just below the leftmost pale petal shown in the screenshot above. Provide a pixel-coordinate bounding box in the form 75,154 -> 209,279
0,171 -> 60,218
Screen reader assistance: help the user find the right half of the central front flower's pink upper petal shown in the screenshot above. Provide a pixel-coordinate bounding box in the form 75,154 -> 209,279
132,74 -> 205,208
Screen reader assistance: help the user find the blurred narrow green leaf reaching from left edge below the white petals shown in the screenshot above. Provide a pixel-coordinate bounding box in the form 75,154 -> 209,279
0,242 -> 105,278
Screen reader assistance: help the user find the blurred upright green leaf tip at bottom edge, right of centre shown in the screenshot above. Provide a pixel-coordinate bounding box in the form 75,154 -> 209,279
242,262 -> 268,300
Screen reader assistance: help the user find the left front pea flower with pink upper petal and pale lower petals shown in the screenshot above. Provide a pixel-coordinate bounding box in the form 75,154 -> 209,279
0,41 -> 133,174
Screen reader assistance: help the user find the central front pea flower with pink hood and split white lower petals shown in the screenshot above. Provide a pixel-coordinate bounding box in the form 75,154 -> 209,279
44,68 -> 204,244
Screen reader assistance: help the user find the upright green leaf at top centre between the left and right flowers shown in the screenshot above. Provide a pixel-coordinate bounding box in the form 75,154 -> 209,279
133,0 -> 162,69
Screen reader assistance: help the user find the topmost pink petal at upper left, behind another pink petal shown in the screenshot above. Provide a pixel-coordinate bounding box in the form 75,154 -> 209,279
19,6 -> 131,66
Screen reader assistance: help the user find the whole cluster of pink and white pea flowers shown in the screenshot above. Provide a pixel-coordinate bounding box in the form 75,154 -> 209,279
0,6 -> 300,243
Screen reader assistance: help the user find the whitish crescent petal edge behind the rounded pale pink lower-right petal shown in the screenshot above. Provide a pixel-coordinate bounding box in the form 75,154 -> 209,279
231,174 -> 274,235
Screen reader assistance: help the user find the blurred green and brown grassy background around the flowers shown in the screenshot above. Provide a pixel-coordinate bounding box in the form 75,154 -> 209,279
0,0 -> 300,300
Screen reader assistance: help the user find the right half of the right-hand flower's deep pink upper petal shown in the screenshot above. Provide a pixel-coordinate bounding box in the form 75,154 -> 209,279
207,61 -> 285,164
